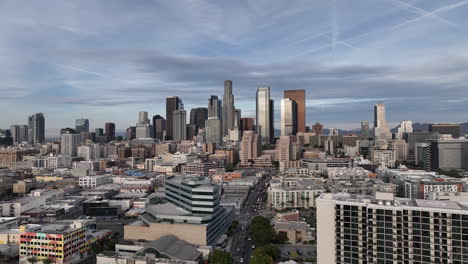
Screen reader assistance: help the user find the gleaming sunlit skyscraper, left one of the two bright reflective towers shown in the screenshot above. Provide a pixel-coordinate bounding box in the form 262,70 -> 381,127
256,86 -> 274,144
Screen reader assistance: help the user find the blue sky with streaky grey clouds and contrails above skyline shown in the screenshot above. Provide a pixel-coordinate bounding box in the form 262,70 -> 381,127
0,0 -> 468,135
